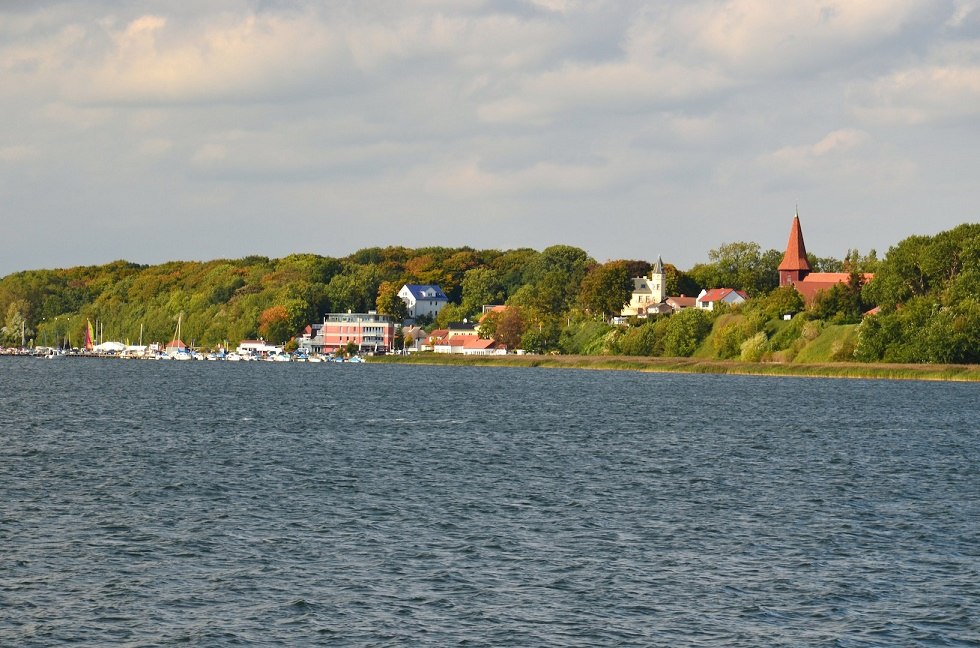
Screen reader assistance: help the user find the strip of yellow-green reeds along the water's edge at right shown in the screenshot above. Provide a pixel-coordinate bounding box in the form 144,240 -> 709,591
367,353 -> 980,382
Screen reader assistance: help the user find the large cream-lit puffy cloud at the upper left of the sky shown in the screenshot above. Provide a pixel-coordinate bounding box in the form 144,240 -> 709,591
66,14 -> 346,104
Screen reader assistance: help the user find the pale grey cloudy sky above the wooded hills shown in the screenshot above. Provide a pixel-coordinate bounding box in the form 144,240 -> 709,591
0,0 -> 980,276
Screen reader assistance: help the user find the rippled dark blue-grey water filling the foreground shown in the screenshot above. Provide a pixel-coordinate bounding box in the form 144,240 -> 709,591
0,358 -> 980,647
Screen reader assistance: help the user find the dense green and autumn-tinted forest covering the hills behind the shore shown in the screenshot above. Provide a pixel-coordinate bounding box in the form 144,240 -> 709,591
0,224 -> 980,363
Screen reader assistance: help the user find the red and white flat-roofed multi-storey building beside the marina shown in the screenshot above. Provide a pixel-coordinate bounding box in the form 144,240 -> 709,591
297,311 -> 395,353
